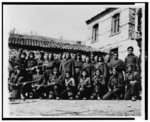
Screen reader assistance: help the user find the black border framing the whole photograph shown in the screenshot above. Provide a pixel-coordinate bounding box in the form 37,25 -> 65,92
1,2 -> 149,120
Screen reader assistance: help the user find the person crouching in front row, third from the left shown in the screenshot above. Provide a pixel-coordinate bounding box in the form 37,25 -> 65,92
46,68 -> 63,100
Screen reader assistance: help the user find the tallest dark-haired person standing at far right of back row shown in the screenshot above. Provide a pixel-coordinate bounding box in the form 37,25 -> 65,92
124,46 -> 140,71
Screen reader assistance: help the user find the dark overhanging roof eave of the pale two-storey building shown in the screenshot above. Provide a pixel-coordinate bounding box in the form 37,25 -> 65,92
86,8 -> 118,24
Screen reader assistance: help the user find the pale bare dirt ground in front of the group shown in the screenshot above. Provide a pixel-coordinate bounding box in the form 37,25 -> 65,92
9,99 -> 141,117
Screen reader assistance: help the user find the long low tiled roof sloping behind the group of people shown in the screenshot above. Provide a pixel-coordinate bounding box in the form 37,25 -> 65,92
9,34 -> 104,52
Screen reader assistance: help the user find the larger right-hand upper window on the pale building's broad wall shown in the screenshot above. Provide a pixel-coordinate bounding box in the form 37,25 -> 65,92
111,13 -> 120,34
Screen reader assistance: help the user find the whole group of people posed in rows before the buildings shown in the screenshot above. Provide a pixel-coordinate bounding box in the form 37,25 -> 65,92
8,46 -> 141,100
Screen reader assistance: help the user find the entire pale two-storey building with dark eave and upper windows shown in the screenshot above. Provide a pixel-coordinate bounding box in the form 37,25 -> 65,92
86,7 -> 142,60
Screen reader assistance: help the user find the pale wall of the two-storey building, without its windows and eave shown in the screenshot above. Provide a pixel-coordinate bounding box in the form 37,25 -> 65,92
86,8 -> 140,59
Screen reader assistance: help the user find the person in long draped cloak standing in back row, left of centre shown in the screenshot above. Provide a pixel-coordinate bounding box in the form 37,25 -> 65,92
59,53 -> 75,79
